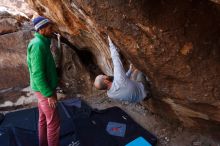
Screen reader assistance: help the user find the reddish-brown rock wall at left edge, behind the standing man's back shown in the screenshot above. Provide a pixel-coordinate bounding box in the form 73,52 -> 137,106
0,13 -> 32,89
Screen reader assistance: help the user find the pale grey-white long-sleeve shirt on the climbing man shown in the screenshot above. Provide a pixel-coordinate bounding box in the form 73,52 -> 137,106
107,38 -> 147,102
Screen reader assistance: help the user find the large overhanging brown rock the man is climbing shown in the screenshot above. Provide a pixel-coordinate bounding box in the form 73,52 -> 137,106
28,0 -> 220,135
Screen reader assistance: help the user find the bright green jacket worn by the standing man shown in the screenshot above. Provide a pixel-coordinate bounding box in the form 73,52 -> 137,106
27,32 -> 58,97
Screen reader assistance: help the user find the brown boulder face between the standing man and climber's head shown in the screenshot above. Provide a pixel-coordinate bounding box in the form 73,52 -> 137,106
57,44 -> 93,96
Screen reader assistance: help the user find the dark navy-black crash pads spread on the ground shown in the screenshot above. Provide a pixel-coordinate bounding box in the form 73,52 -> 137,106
0,99 -> 157,146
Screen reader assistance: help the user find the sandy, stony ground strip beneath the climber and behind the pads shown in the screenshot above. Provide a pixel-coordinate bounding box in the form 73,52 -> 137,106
0,87 -> 220,146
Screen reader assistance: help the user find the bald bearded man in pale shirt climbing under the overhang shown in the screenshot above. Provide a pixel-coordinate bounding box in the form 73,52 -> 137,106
94,36 -> 150,103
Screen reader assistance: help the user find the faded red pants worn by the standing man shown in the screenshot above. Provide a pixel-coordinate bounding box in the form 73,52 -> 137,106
35,92 -> 60,146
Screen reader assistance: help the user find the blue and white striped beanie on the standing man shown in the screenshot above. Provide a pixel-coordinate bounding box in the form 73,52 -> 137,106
33,16 -> 51,31
